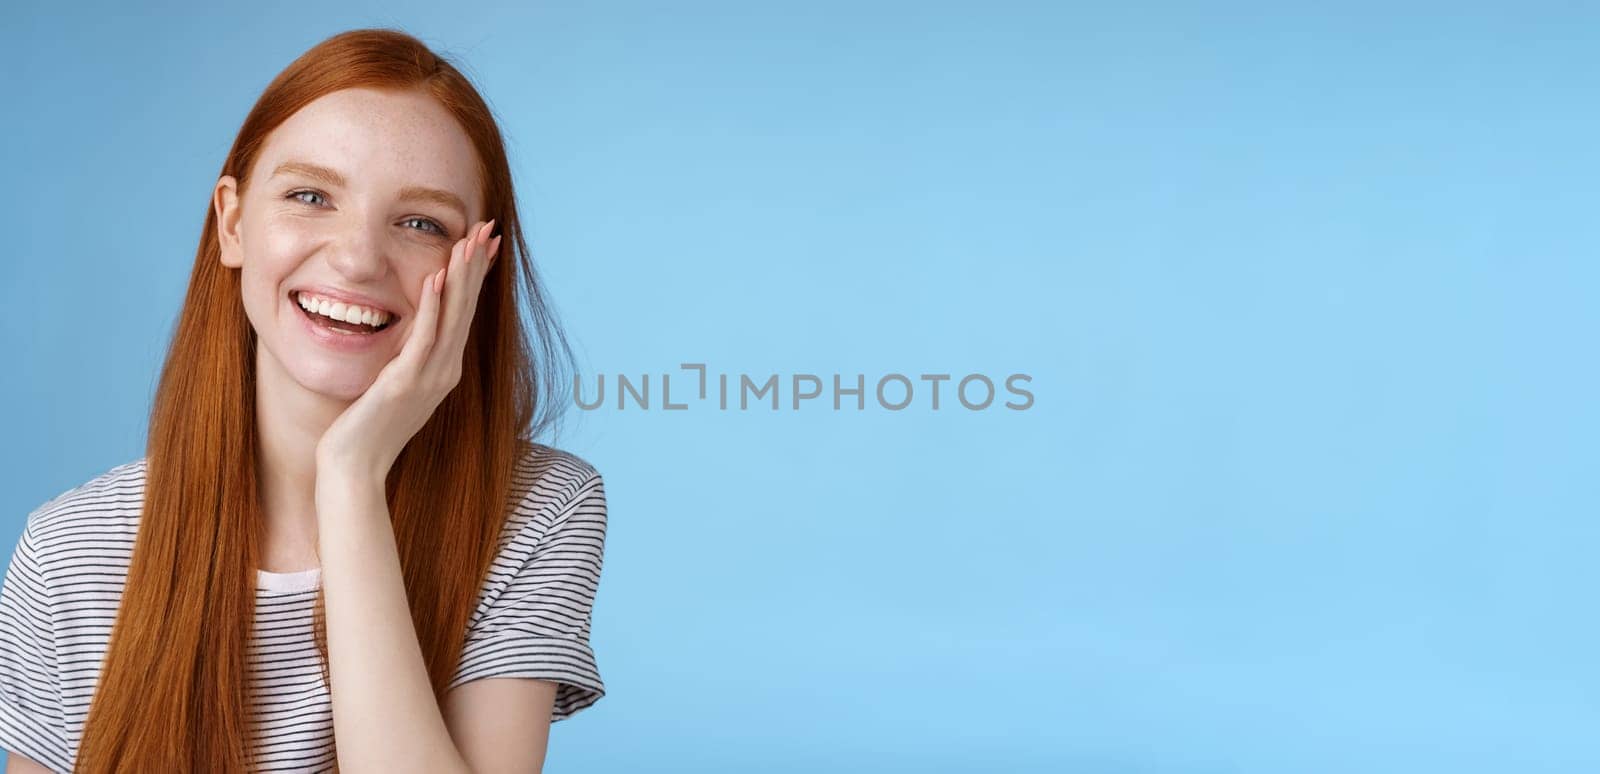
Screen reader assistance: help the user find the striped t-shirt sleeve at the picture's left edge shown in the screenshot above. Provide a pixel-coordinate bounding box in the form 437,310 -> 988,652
0,521 -> 72,771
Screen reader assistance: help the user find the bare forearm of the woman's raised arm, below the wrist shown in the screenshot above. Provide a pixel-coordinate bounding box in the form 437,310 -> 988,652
317,473 -> 469,774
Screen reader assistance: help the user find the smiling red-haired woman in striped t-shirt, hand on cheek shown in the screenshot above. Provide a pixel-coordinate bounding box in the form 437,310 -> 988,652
0,30 -> 606,772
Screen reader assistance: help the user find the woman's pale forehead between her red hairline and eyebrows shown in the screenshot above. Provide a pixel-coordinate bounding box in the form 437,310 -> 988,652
251,88 -> 483,219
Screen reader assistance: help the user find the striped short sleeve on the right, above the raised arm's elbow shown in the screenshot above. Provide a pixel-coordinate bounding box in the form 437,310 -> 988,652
450,469 -> 606,723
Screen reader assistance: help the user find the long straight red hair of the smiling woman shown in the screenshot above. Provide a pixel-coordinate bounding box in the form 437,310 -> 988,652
75,29 -> 576,772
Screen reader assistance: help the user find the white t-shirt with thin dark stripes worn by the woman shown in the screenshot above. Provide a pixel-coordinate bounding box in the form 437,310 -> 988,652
0,440 -> 606,771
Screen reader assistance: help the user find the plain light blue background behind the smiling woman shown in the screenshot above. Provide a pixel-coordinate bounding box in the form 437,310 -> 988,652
0,0 -> 1600,772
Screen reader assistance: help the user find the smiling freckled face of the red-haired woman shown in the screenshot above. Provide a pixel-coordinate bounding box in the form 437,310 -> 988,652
213,88 -> 485,401
